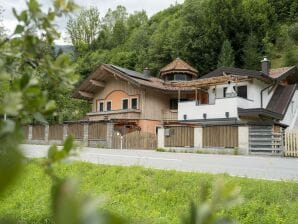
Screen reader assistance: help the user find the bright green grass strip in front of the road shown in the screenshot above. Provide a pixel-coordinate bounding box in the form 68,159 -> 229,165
0,162 -> 298,224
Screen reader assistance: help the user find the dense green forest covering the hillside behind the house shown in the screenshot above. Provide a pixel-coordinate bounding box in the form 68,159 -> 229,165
2,0 -> 298,121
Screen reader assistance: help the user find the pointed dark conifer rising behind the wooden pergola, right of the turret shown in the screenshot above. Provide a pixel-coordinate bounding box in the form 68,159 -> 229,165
217,40 -> 235,67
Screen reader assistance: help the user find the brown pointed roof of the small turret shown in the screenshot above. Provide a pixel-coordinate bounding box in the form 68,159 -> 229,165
160,58 -> 198,77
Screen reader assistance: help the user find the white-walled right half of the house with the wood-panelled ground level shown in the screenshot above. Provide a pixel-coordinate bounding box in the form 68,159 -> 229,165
170,57 -> 298,153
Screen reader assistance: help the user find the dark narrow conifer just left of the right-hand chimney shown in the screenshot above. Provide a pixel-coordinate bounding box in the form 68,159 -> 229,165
243,34 -> 261,70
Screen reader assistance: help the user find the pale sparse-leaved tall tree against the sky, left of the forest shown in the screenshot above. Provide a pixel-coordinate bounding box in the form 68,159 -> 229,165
67,7 -> 101,50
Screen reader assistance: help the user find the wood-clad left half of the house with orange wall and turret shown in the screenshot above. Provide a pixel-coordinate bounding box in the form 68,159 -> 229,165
73,58 -> 198,135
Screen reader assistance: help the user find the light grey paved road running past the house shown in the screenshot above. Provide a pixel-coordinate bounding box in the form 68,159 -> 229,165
22,145 -> 298,181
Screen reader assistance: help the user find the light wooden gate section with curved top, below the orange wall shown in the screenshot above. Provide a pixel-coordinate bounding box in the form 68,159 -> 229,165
112,131 -> 157,149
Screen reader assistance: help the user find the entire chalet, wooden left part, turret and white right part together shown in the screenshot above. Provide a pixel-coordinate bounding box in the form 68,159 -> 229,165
74,58 -> 298,152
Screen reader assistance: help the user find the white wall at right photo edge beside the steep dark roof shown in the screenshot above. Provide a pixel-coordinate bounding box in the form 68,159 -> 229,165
281,90 -> 298,129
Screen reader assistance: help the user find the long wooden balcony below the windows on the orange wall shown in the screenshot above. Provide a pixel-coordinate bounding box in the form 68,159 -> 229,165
87,109 -> 141,120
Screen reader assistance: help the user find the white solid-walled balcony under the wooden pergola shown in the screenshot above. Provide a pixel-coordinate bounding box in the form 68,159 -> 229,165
178,97 -> 257,121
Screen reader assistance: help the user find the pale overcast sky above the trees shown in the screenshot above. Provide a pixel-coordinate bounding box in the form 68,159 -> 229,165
0,0 -> 184,44
